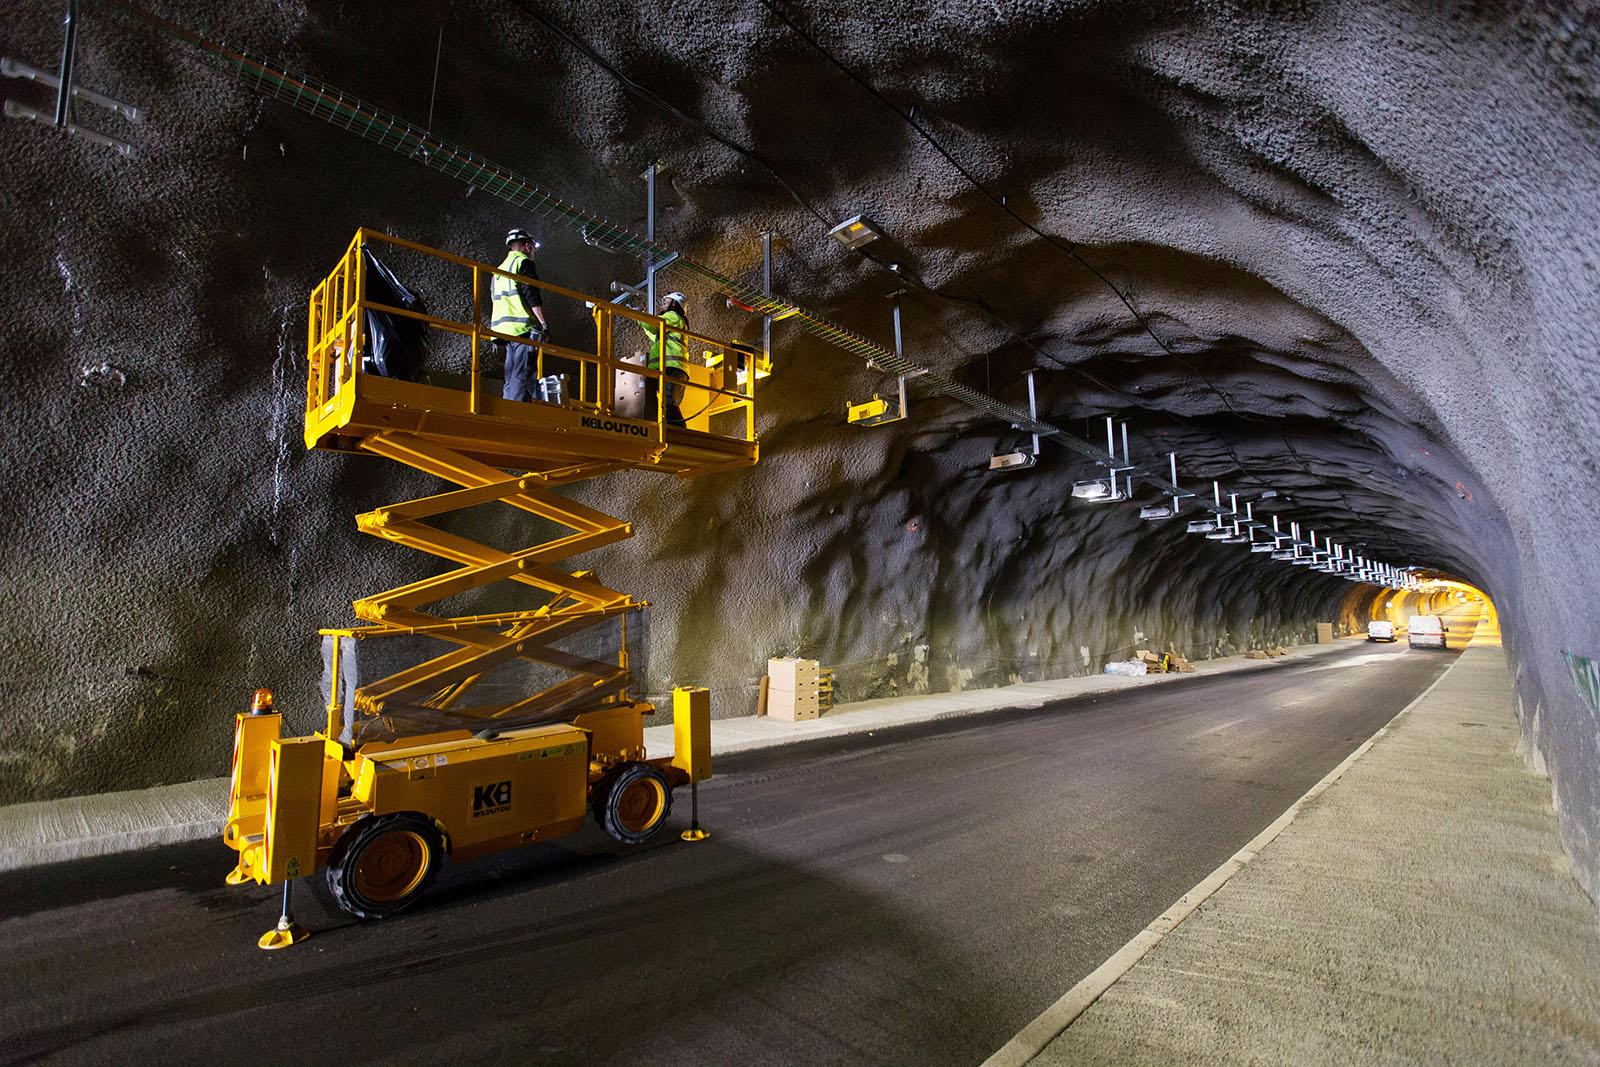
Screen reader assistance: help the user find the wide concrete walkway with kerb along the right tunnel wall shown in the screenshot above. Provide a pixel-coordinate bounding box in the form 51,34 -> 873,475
990,624 -> 1600,1064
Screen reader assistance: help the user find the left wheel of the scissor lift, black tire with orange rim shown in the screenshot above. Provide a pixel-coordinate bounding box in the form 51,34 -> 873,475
328,811 -> 445,918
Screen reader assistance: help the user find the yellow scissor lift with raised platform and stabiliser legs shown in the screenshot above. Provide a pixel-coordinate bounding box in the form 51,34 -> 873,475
222,229 -> 768,947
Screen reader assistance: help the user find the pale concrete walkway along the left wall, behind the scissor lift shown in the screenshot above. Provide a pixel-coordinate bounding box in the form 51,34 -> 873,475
0,640 -> 1349,870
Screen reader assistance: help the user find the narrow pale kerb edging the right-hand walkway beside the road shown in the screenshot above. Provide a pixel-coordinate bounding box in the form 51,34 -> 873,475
984,627 -> 1461,1067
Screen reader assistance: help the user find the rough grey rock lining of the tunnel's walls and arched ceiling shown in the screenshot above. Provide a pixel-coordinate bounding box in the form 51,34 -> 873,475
0,0 -> 1600,888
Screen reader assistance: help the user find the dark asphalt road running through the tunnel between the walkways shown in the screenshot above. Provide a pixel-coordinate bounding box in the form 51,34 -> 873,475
0,627 -> 1467,1067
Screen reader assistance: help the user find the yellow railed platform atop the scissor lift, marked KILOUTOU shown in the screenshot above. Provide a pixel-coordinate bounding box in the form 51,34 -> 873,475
306,229 -> 766,477
